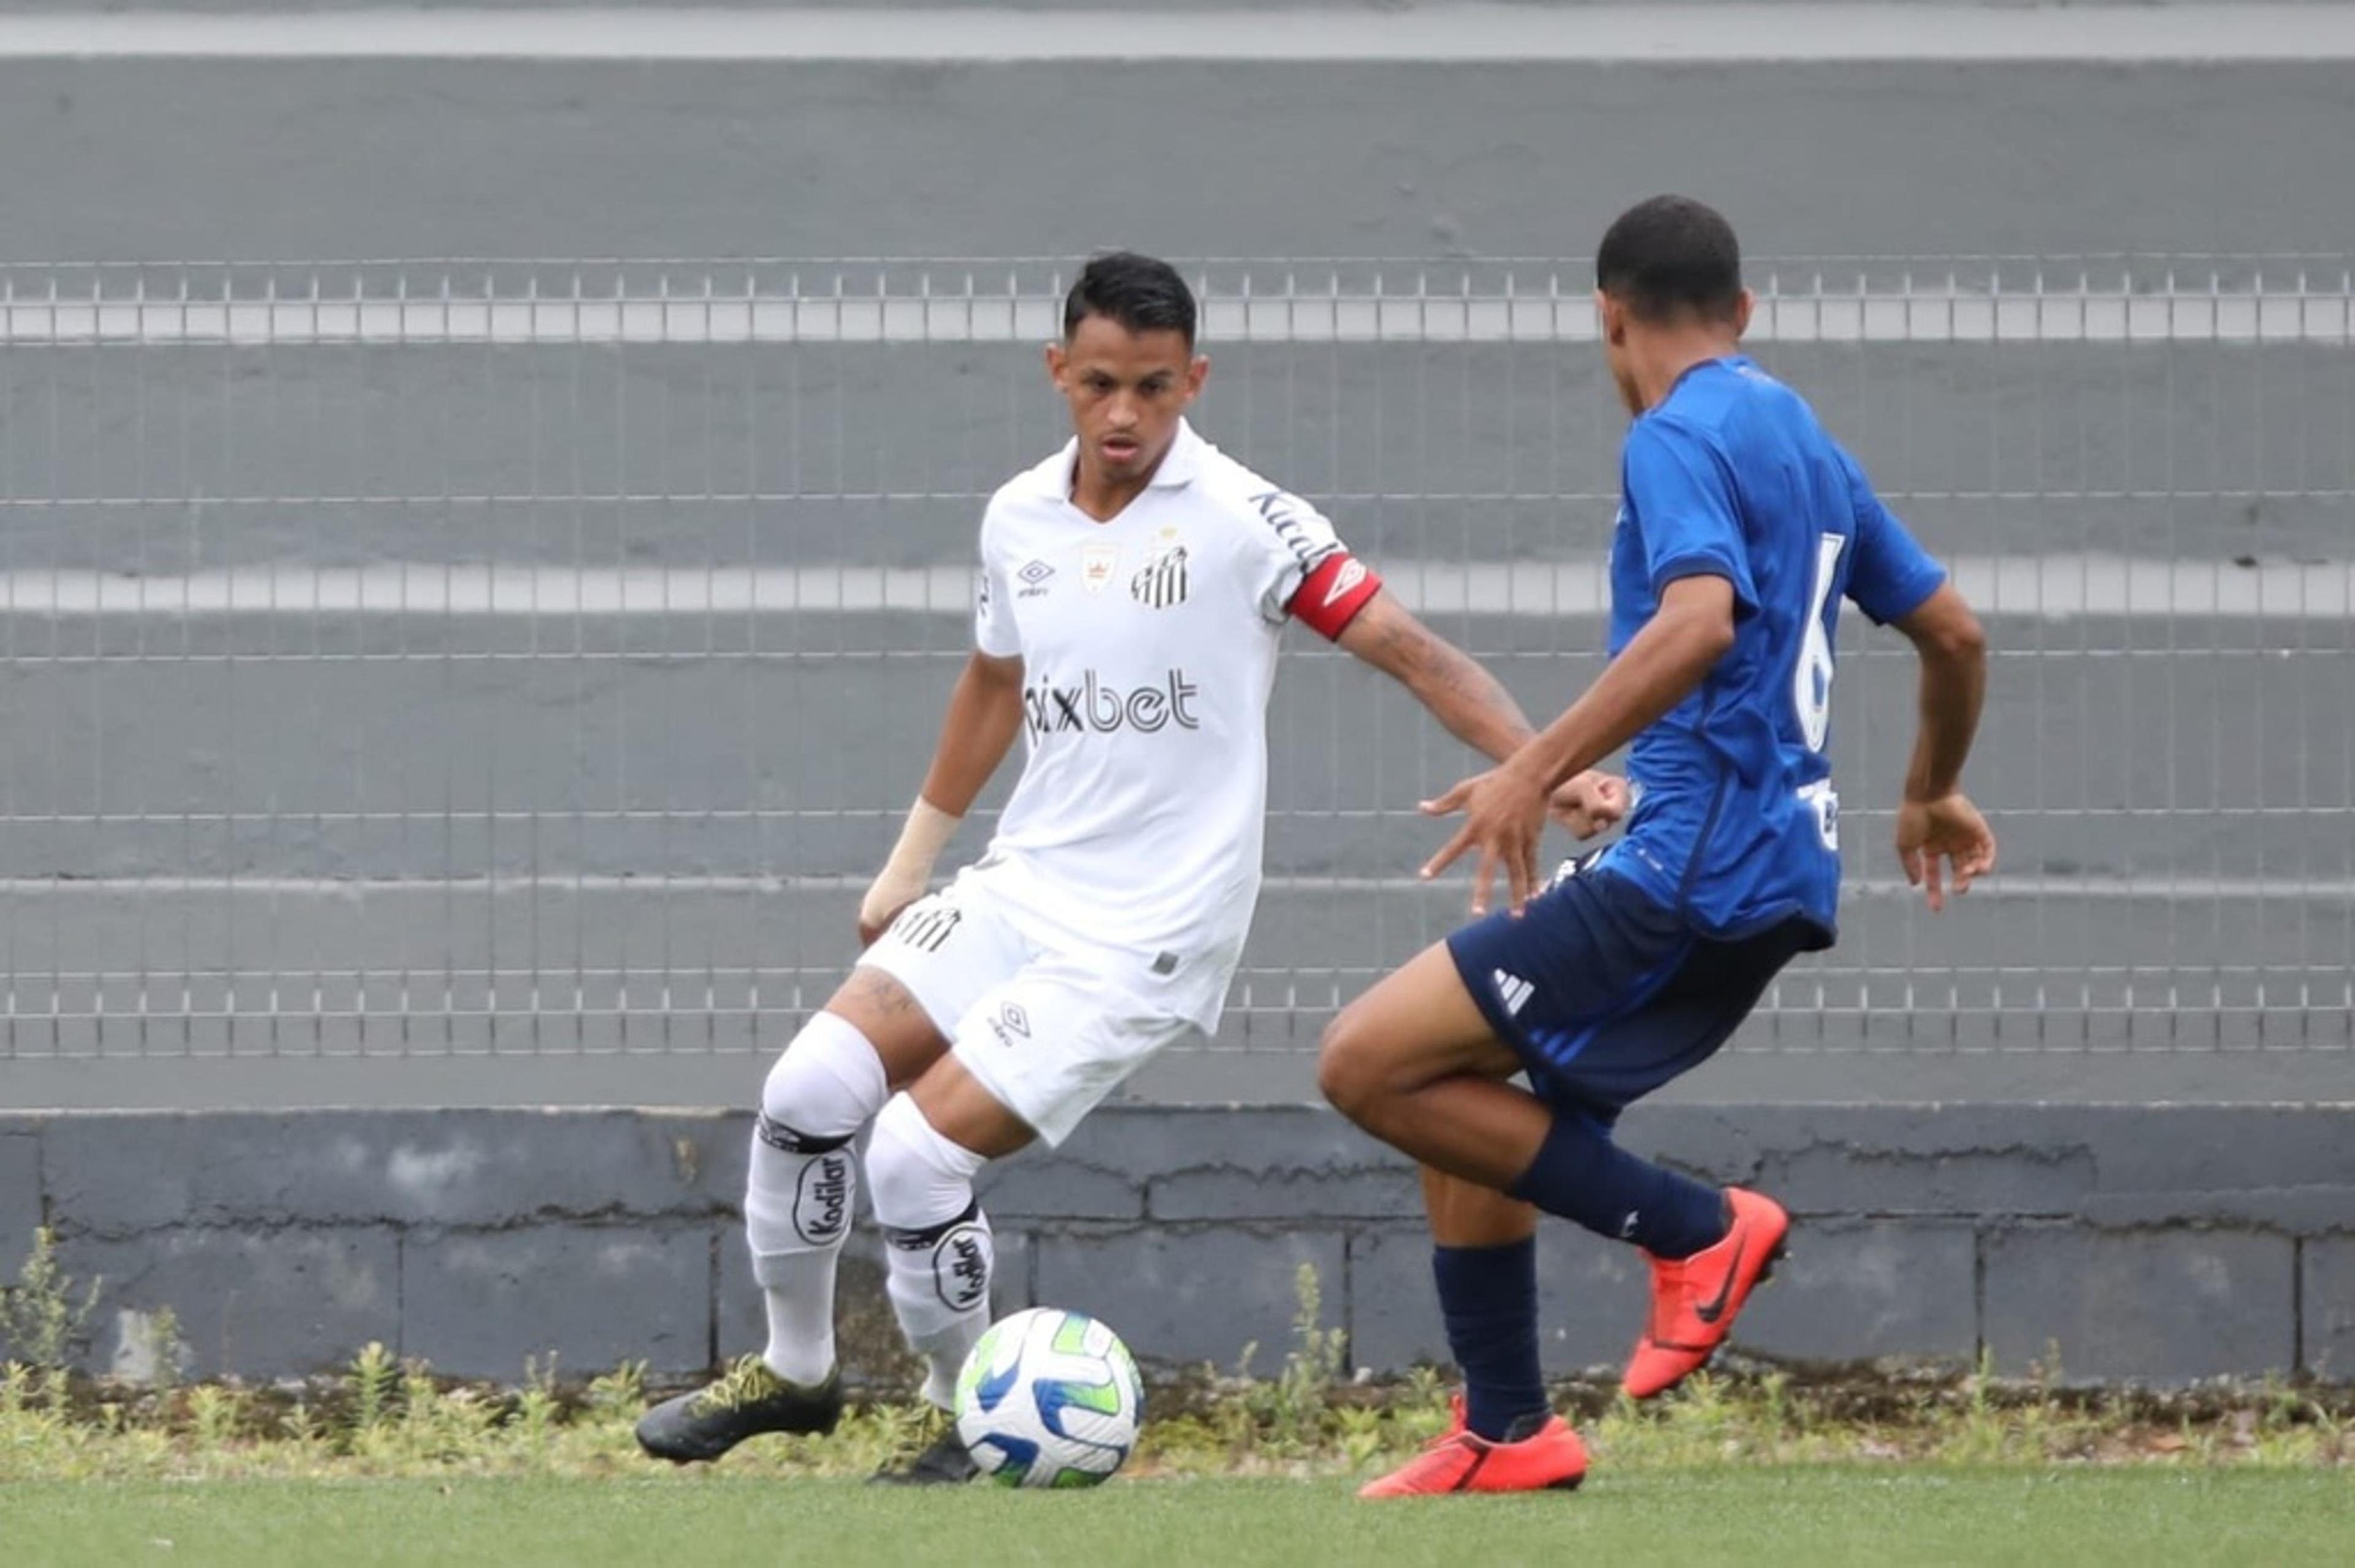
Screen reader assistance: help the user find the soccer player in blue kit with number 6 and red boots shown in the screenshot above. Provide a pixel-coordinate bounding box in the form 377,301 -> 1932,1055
1319,196 -> 1994,1497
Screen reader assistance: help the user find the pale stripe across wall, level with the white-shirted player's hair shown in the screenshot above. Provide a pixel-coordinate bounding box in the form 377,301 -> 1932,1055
0,292 -> 2355,348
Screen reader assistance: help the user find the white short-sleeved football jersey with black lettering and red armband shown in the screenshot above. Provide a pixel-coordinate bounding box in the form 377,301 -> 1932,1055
975,424 -> 1380,1029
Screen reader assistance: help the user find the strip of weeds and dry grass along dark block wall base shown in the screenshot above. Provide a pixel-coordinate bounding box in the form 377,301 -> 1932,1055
0,1344 -> 2355,1483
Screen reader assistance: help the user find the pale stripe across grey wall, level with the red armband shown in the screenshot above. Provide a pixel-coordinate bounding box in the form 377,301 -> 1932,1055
0,556 -> 2355,616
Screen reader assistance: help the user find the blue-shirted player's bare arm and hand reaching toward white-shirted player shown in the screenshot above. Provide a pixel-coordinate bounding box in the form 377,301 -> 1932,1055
1422,575 -> 1733,914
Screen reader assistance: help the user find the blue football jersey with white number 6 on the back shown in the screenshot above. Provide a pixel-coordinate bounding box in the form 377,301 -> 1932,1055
1601,358 -> 1945,944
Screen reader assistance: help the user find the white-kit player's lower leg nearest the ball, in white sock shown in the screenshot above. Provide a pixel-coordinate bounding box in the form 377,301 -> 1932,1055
867,1055 -> 1036,1486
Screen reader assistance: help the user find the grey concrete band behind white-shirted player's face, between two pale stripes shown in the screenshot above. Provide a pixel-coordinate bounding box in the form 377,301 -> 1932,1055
0,329 -> 2355,567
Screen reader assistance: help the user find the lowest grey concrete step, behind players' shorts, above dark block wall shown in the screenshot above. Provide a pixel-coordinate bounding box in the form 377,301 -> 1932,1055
0,852 -> 2355,1078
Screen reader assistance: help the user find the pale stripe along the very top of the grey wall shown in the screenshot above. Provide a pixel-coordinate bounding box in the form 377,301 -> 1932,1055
0,5 -> 2355,64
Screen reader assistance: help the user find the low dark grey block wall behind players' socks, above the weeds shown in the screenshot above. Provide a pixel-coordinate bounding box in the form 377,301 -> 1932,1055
0,1104 -> 2355,1386
